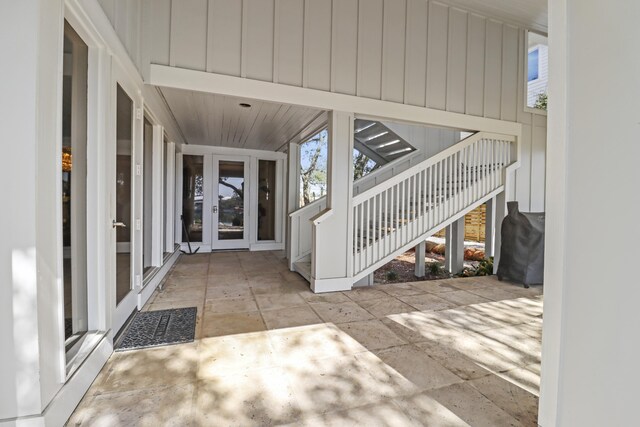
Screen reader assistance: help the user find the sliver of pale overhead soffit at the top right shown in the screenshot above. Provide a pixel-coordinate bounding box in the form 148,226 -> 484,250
439,0 -> 549,34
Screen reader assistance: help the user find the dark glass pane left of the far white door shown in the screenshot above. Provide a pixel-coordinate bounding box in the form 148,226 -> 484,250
182,154 -> 204,242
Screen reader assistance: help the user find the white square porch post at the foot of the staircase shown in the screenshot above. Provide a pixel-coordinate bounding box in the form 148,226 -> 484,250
311,111 -> 353,292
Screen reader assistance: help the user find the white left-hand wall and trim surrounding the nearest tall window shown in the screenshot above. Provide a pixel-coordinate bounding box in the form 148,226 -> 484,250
0,0 -> 183,426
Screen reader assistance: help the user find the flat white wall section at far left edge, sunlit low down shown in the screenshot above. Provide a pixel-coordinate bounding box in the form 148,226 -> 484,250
0,0 -> 65,425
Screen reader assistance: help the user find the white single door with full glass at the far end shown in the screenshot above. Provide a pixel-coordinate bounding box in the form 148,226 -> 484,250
211,155 -> 250,250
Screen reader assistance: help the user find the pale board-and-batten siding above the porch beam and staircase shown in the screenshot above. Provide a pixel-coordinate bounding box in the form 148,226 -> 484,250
136,0 -> 546,210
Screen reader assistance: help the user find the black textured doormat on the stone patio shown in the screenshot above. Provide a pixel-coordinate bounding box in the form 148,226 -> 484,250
115,307 -> 197,351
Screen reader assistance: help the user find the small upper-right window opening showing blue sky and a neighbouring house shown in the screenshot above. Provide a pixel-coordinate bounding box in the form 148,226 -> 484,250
526,32 -> 549,110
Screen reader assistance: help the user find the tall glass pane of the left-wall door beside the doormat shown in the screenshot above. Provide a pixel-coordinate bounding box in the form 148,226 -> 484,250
116,85 -> 133,304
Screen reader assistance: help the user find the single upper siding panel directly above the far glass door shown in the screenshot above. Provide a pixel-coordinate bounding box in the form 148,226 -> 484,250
208,0 -> 242,76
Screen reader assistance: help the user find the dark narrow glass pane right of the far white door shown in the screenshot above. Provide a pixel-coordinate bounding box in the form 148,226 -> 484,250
258,160 -> 276,240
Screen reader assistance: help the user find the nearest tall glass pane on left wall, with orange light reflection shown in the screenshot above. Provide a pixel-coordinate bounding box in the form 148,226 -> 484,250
60,24 -> 88,344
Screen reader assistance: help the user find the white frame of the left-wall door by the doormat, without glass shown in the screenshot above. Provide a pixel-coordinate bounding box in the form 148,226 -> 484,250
107,61 -> 143,334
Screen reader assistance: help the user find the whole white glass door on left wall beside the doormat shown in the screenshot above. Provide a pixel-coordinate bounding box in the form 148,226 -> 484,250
108,64 -> 142,333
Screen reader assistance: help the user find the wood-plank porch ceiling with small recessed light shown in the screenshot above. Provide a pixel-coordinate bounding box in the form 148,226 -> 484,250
159,87 -> 324,151
